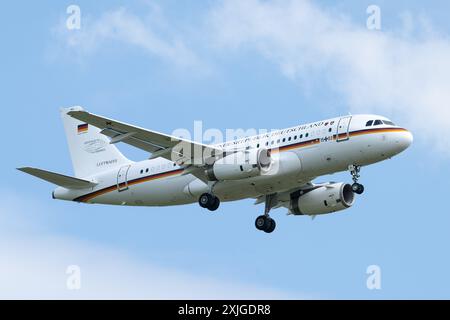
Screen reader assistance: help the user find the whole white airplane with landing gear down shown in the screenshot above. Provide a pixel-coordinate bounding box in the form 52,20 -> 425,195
18,107 -> 413,233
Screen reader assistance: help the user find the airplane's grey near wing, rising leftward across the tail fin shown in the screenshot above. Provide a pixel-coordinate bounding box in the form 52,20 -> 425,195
68,111 -> 223,165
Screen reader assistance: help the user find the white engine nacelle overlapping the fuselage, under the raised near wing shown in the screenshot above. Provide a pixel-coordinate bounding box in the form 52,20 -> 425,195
206,149 -> 272,181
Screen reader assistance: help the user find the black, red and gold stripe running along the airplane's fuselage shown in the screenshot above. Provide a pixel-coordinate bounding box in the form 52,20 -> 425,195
73,128 -> 408,202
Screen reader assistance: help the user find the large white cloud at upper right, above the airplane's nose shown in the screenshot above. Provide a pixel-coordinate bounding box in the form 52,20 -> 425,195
208,0 -> 450,155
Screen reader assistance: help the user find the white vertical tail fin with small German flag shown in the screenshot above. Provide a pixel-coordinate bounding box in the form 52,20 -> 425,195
61,107 -> 131,178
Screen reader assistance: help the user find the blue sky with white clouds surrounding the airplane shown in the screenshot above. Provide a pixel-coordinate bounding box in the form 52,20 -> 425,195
0,0 -> 450,299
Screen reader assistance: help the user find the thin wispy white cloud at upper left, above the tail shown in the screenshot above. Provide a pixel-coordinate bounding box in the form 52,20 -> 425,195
54,5 -> 205,68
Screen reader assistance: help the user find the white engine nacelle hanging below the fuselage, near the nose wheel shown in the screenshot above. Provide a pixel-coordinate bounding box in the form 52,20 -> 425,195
291,183 -> 355,216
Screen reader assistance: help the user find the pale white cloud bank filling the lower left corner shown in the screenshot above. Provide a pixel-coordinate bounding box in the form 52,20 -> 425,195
0,190 -> 301,299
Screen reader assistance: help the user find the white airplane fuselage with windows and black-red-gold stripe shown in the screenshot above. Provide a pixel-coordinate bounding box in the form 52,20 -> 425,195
53,115 -> 412,206
